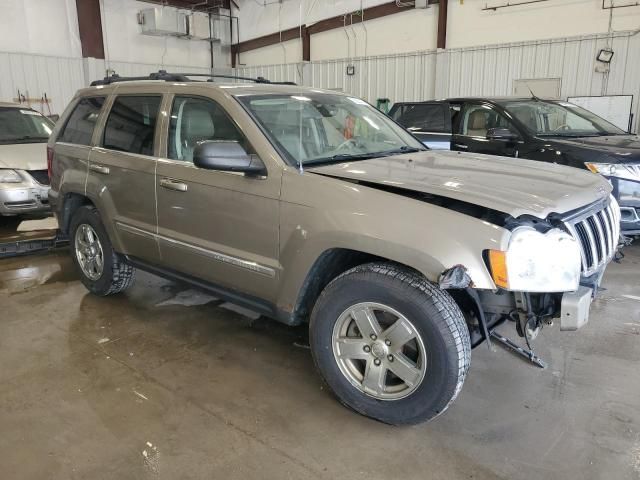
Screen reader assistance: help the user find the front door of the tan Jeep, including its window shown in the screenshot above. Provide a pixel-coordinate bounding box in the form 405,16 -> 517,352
156,95 -> 281,304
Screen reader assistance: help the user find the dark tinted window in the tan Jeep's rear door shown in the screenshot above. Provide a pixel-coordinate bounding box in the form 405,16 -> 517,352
102,95 -> 162,155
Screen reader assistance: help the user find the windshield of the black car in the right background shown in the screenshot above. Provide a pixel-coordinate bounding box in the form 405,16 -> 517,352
503,99 -> 626,137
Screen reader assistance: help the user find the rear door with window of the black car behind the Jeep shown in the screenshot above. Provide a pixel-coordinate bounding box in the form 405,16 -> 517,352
389,102 -> 451,150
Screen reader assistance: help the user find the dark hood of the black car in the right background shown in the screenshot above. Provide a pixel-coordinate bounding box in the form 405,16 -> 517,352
540,135 -> 640,163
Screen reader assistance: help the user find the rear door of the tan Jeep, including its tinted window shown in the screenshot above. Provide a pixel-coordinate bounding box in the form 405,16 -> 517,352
87,90 -> 162,262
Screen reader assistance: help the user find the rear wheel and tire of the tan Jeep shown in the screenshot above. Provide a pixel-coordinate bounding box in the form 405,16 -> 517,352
69,205 -> 135,296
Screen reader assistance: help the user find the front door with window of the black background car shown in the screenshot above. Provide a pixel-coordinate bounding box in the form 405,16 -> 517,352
451,103 -> 522,157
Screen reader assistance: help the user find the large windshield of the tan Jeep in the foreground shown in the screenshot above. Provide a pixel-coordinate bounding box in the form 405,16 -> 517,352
238,93 -> 425,165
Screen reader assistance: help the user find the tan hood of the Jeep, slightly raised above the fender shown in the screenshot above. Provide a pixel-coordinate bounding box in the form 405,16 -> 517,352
307,151 -> 611,218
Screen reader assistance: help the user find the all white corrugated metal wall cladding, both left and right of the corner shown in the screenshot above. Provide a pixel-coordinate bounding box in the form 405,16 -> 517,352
5,32 -> 640,129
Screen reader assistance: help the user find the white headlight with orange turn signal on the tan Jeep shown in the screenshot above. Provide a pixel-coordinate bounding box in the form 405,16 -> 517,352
489,227 -> 582,292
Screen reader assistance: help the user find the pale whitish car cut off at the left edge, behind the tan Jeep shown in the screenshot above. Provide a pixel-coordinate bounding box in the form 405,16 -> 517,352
0,103 -> 54,216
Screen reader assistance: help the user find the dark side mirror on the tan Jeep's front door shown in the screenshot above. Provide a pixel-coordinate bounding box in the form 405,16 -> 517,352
193,140 -> 267,175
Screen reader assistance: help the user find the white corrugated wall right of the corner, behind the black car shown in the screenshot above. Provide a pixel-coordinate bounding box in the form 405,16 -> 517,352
236,32 -> 640,131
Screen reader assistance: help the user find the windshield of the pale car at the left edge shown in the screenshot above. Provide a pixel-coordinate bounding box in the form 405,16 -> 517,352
0,108 -> 53,144
